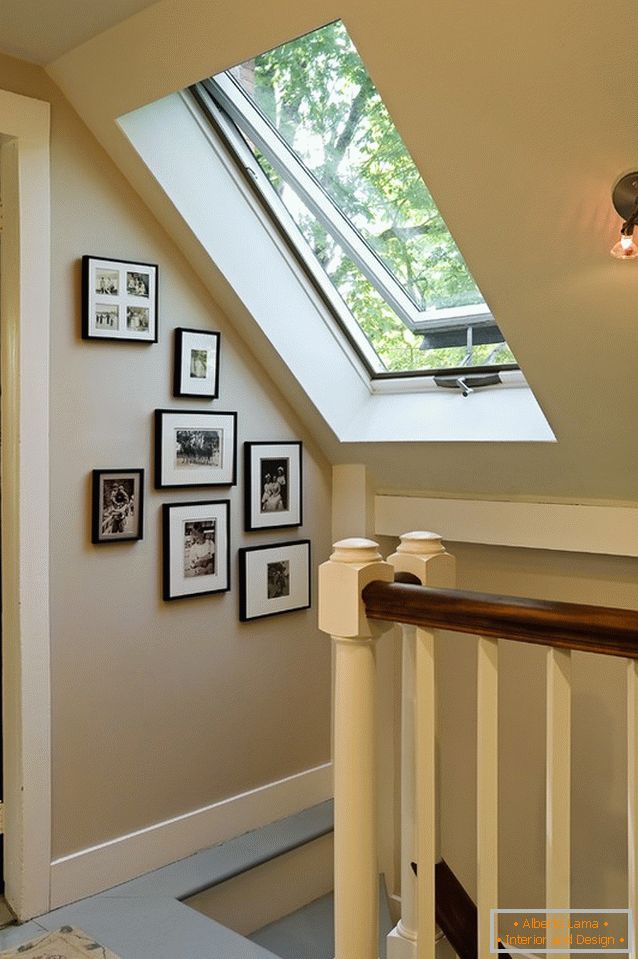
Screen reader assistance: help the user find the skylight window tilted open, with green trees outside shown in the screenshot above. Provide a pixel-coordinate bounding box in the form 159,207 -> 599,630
198,21 -> 516,374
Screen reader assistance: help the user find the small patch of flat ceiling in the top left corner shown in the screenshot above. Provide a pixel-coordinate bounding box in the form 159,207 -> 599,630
0,0 -> 156,63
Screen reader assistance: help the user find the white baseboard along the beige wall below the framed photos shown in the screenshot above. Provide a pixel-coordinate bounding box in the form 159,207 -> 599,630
51,763 -> 332,909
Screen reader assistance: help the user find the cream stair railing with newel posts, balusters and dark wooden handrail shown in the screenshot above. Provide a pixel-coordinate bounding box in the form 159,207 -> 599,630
319,532 -> 638,959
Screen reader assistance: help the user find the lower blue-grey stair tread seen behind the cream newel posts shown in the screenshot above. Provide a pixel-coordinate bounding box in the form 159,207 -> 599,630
248,877 -> 393,959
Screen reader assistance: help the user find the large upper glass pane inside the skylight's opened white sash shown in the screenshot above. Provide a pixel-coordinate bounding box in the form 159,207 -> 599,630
230,21 -> 484,310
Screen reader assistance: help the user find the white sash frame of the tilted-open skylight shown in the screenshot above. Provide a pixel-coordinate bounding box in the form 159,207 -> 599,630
198,72 -> 495,333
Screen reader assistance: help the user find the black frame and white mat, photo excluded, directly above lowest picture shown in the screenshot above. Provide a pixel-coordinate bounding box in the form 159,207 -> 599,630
244,441 -> 303,530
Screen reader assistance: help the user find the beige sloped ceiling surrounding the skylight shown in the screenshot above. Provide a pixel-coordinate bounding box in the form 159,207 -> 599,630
38,0 -> 638,502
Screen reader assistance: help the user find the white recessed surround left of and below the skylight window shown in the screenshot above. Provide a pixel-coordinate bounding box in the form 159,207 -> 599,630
118,92 -> 555,444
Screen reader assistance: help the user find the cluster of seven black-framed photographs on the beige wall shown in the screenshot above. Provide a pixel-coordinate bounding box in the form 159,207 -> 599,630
82,256 -> 311,622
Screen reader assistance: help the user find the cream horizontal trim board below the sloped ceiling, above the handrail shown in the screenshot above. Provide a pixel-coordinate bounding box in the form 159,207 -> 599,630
375,495 -> 638,556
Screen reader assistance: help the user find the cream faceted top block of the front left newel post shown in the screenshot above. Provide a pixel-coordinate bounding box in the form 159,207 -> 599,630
319,537 -> 394,640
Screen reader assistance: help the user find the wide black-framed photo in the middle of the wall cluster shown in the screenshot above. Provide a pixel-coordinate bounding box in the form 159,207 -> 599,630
155,410 -> 237,489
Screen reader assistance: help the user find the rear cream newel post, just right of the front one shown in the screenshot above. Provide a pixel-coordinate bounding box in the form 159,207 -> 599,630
387,532 -> 456,959
